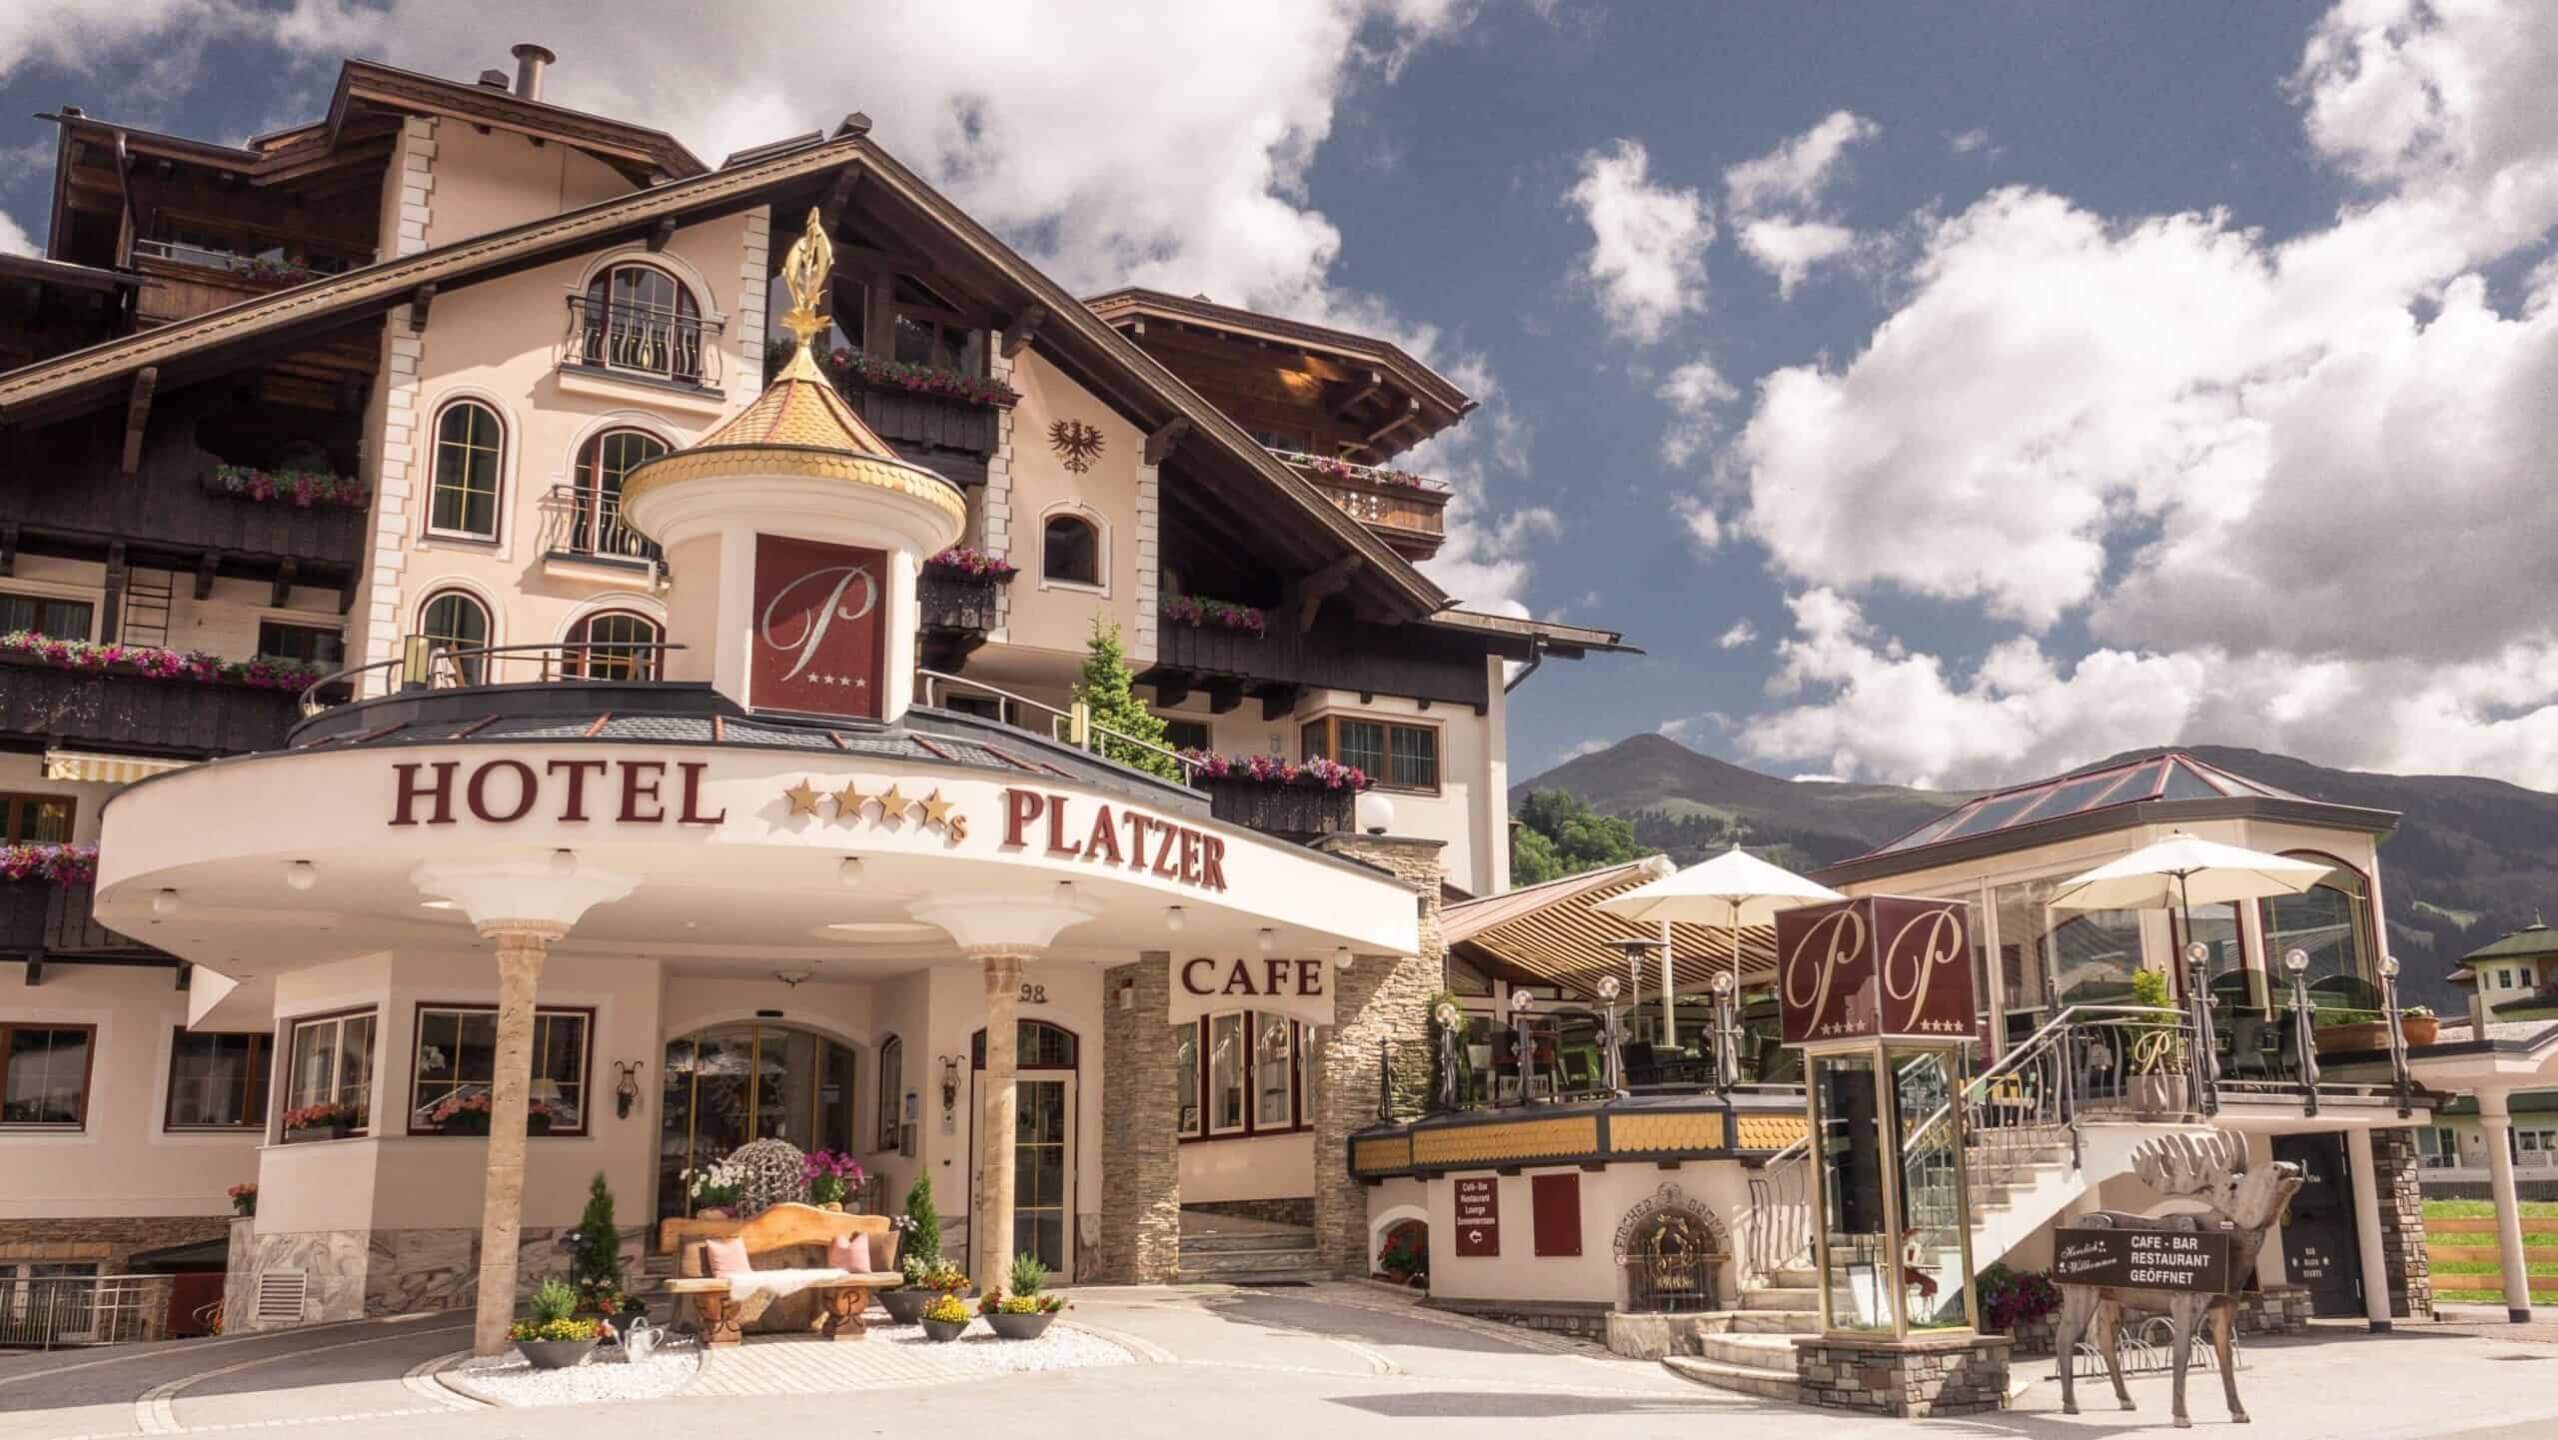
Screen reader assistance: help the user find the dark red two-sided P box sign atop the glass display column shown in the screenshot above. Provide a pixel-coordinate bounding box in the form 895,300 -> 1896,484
1775,895 -> 1975,1044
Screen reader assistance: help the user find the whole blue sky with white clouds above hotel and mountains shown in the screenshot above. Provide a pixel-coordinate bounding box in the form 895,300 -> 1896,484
0,0 -> 2558,788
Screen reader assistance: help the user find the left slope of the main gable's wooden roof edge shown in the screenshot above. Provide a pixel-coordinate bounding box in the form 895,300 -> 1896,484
0,141 -> 862,425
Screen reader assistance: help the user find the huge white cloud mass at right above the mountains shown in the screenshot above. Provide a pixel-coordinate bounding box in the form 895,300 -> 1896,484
1732,0 -> 2558,788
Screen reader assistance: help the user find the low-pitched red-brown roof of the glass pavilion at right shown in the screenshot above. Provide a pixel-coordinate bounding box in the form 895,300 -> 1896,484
1814,749 -> 2397,885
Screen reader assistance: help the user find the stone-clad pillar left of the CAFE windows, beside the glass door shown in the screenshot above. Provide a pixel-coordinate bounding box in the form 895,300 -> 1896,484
1077,951 -> 1182,1284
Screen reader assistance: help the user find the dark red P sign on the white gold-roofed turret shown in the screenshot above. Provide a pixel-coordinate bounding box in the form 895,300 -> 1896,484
747,535 -> 888,719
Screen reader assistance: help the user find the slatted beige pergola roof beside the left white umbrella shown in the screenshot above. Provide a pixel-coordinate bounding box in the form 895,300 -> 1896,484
1440,854 -> 1775,1000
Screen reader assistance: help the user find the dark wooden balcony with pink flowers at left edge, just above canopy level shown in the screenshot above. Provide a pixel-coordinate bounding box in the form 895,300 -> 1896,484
0,655 -> 299,757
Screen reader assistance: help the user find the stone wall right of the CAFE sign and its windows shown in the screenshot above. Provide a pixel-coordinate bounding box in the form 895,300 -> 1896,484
1315,834 -> 1448,1276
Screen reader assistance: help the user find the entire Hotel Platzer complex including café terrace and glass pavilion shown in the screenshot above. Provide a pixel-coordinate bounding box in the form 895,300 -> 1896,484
0,46 -> 2430,1389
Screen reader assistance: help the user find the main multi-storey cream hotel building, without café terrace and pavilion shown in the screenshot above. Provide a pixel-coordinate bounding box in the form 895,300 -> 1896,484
0,46 -> 1619,1330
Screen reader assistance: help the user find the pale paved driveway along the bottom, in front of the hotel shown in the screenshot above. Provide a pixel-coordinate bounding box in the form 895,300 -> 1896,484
0,1287 -> 2558,1440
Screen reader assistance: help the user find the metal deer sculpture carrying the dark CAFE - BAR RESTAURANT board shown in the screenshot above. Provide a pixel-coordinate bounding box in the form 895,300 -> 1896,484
2054,1131 -> 2300,1430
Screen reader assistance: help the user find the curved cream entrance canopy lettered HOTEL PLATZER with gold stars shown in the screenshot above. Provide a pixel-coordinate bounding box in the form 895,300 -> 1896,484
97,719 -> 1420,1017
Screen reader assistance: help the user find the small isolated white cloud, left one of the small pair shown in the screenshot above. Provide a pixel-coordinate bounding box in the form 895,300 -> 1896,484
1565,141 -> 1714,343
